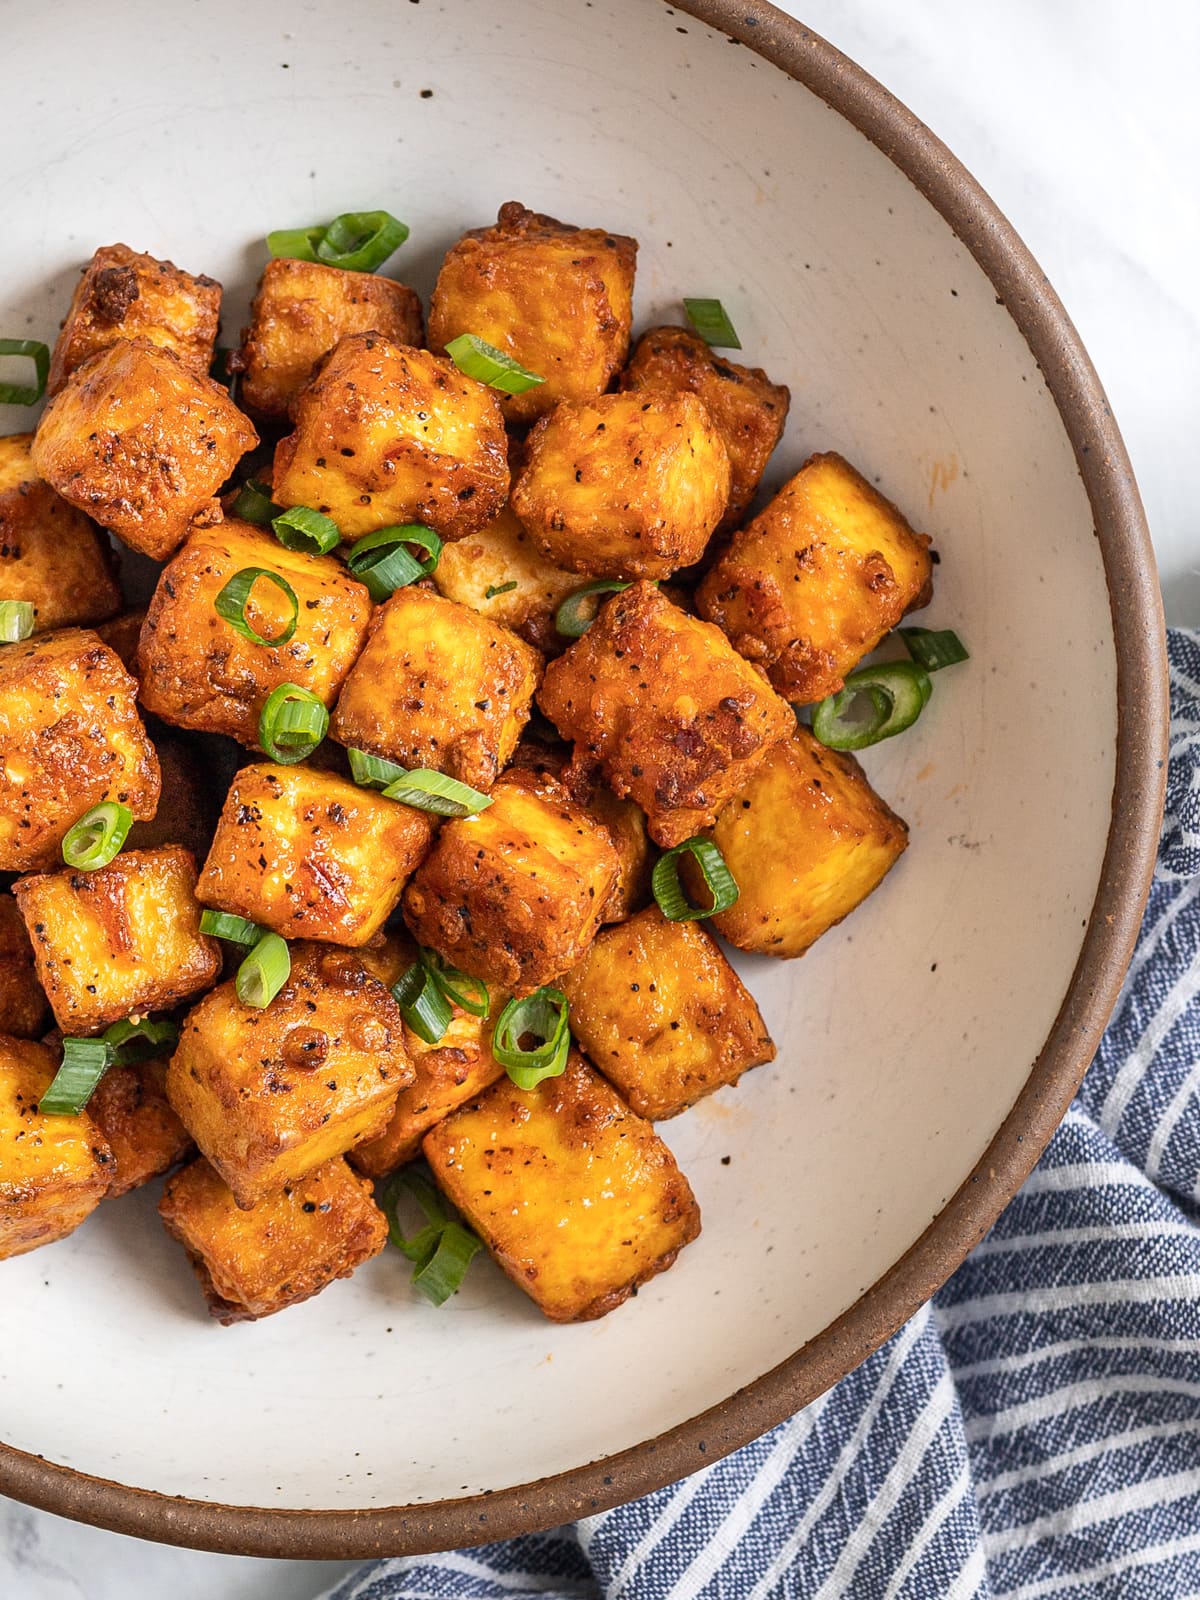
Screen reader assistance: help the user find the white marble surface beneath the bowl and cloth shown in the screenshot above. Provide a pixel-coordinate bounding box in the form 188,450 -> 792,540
0,0 -> 1200,1600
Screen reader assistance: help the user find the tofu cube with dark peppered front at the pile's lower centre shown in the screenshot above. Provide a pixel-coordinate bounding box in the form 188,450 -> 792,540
403,770 -> 619,995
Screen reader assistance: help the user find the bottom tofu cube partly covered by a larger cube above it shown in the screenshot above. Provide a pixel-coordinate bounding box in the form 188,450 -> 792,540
158,1157 -> 387,1326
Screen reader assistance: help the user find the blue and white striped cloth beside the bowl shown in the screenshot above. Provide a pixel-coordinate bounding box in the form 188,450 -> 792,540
321,632 -> 1200,1600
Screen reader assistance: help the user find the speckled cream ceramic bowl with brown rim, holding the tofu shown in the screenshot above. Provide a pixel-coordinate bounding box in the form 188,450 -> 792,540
0,0 -> 1166,1557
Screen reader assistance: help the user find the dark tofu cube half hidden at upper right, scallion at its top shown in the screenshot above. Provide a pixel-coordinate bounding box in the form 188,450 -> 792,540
621,328 -> 792,531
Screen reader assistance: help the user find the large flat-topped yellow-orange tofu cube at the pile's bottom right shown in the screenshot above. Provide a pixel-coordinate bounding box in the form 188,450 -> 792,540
424,1051 -> 699,1322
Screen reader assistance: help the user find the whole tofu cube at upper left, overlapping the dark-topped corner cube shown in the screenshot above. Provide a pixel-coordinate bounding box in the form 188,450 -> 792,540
34,339 -> 258,562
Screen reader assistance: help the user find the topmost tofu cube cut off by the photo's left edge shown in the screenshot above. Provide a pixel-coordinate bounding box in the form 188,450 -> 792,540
0,434 -> 122,634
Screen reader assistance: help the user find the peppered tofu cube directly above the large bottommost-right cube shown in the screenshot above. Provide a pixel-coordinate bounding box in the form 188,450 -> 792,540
560,906 -> 774,1122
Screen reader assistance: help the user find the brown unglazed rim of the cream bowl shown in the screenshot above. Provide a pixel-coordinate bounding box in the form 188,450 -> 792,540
0,0 -> 1168,1560
